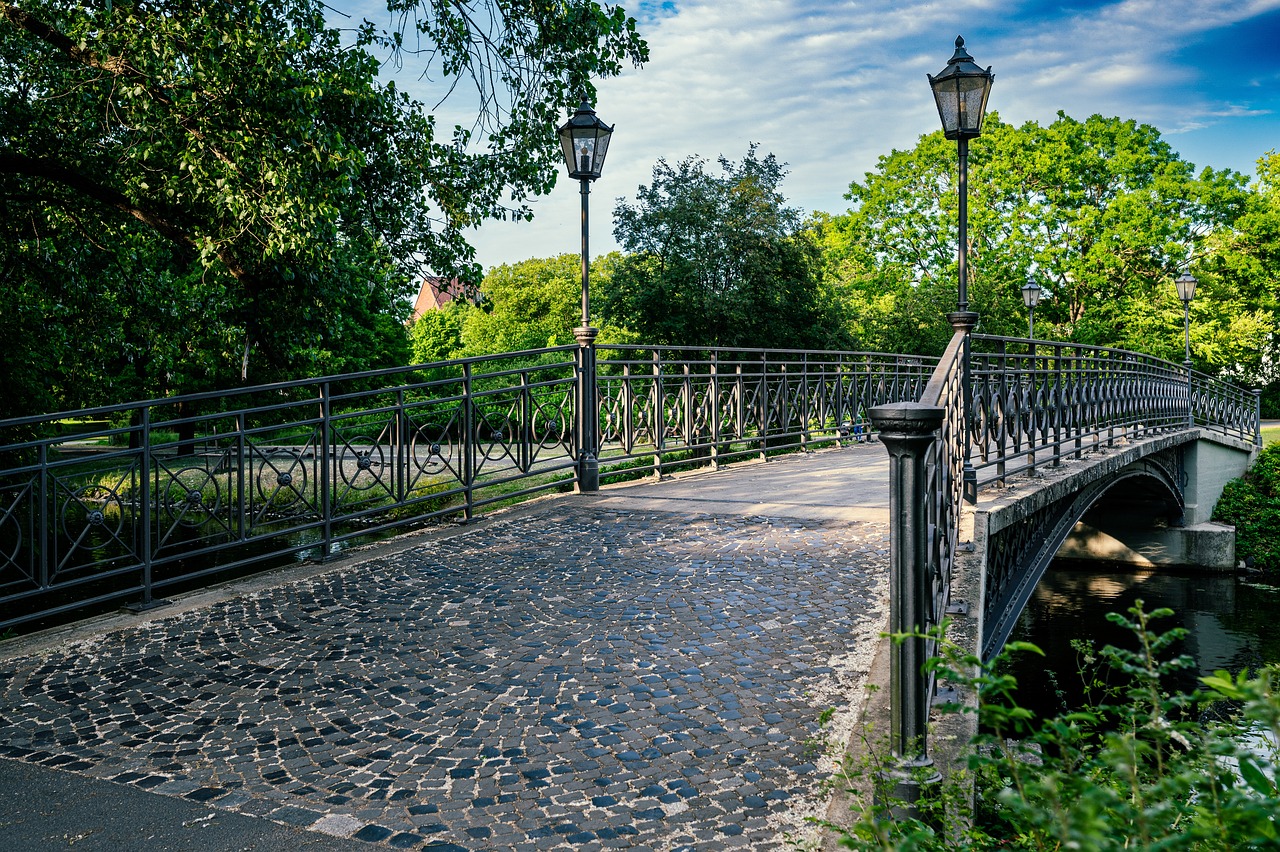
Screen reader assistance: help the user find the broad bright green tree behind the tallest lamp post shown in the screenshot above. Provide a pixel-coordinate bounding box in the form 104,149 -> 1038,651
824,113 -> 1249,366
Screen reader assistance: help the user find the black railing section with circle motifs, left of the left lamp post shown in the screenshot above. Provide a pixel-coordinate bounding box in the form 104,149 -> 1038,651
0,347 -> 577,628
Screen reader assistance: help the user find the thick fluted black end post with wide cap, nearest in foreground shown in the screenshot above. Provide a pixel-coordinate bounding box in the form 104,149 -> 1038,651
869,399 -> 947,811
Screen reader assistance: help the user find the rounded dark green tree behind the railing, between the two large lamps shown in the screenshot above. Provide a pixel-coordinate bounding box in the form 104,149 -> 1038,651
600,146 -> 844,347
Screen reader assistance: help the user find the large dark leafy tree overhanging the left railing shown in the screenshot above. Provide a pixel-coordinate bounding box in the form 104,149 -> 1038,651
0,0 -> 645,413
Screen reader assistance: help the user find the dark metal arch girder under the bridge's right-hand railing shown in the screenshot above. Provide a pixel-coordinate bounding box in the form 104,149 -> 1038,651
974,441 -> 1185,660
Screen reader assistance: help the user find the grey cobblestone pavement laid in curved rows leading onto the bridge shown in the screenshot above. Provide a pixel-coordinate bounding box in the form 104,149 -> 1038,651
0,457 -> 888,851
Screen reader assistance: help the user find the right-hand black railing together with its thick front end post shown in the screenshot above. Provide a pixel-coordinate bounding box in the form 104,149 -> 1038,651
870,327 -> 1261,775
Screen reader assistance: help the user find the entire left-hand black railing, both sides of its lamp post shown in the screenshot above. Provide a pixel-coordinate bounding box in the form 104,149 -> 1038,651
0,345 -> 933,629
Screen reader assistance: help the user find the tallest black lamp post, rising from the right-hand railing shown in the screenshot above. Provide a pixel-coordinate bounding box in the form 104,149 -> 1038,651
928,36 -> 996,503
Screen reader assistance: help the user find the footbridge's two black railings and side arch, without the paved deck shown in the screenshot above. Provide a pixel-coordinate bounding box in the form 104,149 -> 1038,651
0,329 -> 1260,834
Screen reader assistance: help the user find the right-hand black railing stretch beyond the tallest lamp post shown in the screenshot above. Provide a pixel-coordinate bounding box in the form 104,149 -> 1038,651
970,334 -> 1260,482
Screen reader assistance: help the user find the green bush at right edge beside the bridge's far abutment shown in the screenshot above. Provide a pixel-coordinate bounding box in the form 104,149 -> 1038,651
1213,444 -> 1280,571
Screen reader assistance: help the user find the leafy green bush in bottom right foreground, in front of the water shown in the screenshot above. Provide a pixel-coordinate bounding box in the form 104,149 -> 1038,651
831,601 -> 1280,851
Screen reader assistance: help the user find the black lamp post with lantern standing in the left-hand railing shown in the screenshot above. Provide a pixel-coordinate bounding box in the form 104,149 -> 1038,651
557,97 -> 613,491
